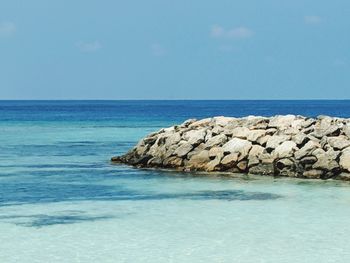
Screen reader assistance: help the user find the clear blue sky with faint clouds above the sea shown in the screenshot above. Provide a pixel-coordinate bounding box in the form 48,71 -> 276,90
0,0 -> 350,99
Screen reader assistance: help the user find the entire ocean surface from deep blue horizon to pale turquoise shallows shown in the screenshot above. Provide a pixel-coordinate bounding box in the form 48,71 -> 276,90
0,101 -> 350,263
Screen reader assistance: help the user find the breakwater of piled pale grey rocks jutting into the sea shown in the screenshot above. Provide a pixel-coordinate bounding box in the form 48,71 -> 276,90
112,115 -> 350,180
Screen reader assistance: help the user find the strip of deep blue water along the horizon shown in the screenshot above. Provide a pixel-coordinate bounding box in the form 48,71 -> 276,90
0,100 -> 350,125
